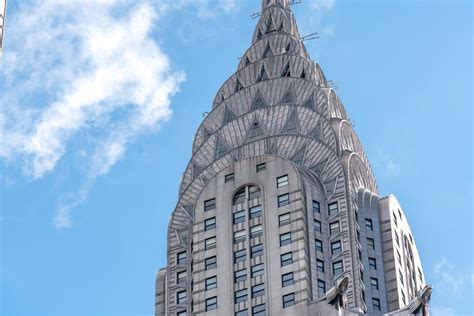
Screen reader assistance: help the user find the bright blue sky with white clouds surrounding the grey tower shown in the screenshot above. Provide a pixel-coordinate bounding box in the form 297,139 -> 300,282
0,0 -> 474,316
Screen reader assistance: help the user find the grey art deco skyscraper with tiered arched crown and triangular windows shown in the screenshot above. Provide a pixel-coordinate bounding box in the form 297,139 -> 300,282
156,0 -> 431,316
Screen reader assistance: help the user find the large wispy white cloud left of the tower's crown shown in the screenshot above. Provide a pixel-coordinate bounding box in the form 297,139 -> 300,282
0,0 -> 184,228
